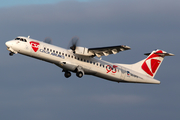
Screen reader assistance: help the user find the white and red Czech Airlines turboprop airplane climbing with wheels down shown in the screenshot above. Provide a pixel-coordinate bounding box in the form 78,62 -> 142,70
5,36 -> 174,84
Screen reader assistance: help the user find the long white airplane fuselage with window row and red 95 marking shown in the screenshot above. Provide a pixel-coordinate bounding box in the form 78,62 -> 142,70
6,37 -> 160,84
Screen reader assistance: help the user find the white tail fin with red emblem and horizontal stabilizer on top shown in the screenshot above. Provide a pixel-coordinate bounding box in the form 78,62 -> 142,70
119,50 -> 174,78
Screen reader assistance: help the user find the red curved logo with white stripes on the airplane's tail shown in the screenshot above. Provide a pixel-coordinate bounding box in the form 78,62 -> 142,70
141,50 -> 163,77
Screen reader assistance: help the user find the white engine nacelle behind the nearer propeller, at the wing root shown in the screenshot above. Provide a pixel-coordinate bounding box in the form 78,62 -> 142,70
75,47 -> 94,56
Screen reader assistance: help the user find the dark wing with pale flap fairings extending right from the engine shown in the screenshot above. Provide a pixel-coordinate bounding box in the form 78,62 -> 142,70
88,45 -> 131,57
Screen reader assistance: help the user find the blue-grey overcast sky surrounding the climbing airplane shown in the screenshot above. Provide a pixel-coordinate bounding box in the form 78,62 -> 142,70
0,0 -> 180,120
